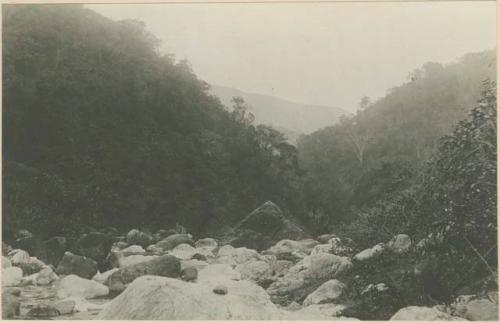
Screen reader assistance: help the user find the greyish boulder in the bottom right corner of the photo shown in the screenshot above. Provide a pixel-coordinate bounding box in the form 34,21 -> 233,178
452,295 -> 498,321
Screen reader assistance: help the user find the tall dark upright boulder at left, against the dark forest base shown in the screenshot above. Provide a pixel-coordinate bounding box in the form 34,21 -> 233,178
73,232 -> 114,270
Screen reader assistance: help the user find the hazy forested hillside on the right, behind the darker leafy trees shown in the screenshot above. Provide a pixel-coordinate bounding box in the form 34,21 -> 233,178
298,51 -> 496,228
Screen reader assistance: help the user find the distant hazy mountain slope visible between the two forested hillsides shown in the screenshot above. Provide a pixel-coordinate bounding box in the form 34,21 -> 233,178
210,85 -> 347,139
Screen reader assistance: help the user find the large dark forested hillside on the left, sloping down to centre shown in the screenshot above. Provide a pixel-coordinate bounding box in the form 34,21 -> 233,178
3,5 -> 300,243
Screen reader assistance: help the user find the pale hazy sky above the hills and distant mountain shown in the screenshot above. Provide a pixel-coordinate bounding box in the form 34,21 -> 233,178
88,1 -> 496,110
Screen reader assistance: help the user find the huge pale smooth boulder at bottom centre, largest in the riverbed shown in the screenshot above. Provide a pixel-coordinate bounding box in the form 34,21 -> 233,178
97,276 -> 281,320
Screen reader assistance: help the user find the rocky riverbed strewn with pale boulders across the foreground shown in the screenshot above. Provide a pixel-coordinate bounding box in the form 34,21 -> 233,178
2,204 -> 498,320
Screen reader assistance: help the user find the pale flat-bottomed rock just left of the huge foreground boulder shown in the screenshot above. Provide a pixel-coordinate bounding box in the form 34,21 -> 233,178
56,275 -> 109,298
